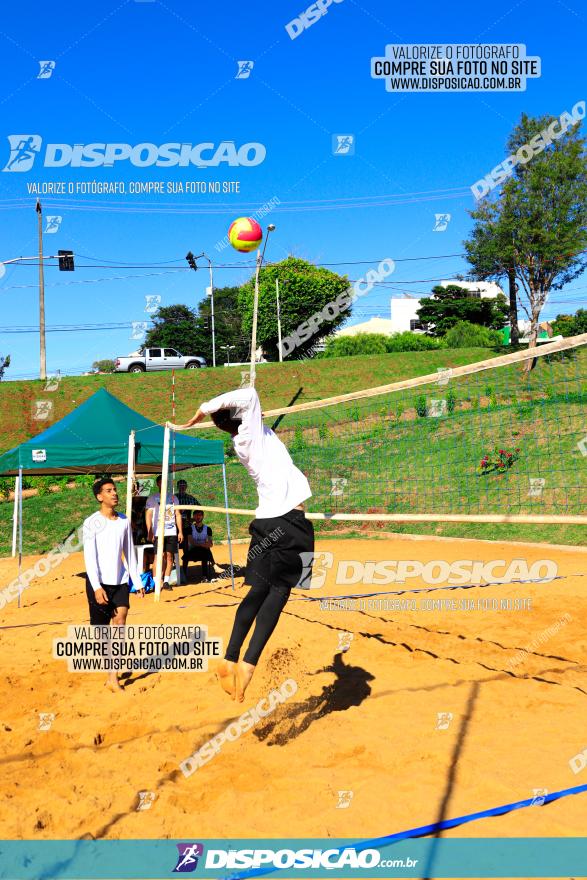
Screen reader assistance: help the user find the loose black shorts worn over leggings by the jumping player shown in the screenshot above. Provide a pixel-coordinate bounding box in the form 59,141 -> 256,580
245,509 -> 314,589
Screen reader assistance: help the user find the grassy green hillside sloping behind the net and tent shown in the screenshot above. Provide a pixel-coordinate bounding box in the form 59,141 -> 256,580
0,349 -> 587,555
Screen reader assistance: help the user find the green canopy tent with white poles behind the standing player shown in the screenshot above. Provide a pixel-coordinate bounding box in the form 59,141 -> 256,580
0,388 -> 232,600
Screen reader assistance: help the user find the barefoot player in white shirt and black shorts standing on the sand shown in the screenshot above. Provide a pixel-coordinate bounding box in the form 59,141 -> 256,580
83,477 -> 144,691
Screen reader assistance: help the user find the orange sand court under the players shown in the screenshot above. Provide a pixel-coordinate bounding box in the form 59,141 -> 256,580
0,536 -> 587,840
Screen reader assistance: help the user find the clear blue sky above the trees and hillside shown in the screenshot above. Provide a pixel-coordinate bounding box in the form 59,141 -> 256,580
0,0 -> 587,378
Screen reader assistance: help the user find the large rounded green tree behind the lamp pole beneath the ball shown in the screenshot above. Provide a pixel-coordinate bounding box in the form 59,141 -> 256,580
239,256 -> 351,360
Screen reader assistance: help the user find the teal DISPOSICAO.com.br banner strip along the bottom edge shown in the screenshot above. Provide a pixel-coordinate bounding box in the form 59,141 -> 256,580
0,837 -> 587,880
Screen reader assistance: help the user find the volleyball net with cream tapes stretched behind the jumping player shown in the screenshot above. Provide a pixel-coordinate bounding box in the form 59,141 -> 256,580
150,334 -> 587,596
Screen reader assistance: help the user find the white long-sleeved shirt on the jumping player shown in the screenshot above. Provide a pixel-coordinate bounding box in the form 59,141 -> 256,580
200,388 -> 312,519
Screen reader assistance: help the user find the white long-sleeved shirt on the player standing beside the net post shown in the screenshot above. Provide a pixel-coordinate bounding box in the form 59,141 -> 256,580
83,510 -> 142,590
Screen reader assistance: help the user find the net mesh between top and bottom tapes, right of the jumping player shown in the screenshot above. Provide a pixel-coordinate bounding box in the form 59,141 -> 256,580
278,347 -> 587,515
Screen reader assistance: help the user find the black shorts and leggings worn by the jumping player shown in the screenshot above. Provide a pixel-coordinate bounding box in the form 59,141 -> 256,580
224,509 -> 314,666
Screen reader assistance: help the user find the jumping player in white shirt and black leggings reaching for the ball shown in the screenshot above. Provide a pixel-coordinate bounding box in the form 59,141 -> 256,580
170,388 -> 314,702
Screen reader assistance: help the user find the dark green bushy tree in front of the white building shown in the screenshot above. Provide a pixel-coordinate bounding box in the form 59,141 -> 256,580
418,284 -> 507,337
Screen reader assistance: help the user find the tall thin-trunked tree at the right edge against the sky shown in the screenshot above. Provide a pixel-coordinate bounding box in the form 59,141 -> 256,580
465,108 -> 587,360
